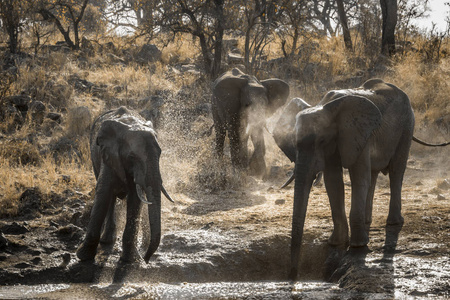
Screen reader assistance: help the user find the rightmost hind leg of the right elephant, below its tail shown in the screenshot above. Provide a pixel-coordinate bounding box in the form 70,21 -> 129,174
387,147 -> 409,225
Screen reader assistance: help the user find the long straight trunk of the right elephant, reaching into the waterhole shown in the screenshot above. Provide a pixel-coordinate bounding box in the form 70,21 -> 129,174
289,153 -> 314,280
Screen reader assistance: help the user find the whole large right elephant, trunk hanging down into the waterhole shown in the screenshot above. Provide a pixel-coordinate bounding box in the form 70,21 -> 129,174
284,79 -> 414,279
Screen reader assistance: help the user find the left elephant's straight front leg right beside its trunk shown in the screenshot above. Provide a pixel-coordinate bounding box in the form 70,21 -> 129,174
120,185 -> 141,262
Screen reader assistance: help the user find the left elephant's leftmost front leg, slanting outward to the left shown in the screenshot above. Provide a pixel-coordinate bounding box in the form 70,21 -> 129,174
77,165 -> 117,261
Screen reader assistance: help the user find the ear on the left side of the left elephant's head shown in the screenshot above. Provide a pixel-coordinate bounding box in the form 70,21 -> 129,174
96,120 -> 127,182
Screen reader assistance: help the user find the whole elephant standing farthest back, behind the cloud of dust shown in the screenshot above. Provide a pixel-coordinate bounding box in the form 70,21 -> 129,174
212,69 -> 289,175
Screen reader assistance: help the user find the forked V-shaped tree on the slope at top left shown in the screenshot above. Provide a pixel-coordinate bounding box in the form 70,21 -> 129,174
37,0 -> 89,50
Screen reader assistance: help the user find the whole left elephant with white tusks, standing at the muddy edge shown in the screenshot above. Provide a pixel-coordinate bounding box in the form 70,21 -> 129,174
77,106 -> 173,262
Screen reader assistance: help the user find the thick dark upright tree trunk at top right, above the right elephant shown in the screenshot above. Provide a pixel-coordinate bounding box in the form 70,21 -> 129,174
380,0 -> 397,56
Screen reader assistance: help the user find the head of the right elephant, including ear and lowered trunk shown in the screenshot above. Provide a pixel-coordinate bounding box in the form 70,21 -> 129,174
290,96 -> 382,279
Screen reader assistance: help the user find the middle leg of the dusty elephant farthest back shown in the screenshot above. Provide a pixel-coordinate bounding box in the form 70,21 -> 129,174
228,122 -> 248,169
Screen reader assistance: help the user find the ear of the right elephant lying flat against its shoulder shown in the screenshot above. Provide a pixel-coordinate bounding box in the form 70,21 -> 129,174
323,96 -> 382,168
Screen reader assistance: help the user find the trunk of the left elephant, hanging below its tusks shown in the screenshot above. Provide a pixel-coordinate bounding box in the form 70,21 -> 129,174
144,176 -> 162,263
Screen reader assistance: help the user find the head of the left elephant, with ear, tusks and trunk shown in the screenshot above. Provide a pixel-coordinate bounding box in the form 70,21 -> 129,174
93,115 -> 171,262
